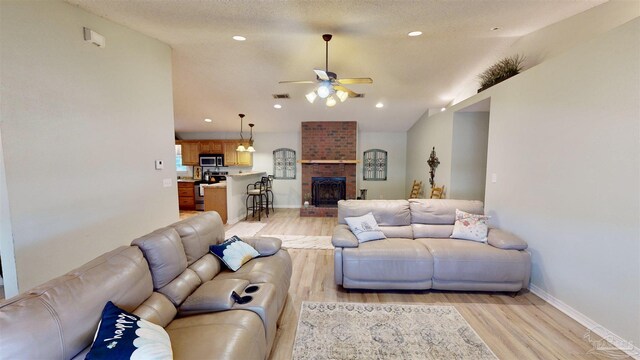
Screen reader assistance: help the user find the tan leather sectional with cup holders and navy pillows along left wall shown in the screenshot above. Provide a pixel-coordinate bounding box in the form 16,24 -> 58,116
0,212 -> 291,359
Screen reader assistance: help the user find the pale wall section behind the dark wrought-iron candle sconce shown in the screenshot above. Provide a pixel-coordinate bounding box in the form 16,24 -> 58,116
406,110 -> 453,197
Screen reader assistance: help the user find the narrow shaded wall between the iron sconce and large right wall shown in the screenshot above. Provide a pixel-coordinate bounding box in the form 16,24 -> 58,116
445,112 -> 489,201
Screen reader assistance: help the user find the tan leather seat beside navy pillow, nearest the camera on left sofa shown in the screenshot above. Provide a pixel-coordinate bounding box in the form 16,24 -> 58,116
166,310 -> 267,360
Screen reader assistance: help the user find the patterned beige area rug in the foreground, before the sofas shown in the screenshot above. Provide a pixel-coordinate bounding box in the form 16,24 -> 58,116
293,302 -> 497,360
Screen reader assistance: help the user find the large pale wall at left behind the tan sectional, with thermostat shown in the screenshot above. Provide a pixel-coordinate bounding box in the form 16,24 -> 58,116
0,1 -> 178,291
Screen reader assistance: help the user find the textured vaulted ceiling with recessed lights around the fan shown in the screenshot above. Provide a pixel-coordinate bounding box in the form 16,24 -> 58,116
68,0 -> 604,132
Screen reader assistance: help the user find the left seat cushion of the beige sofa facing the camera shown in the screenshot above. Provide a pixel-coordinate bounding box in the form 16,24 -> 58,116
342,238 -> 433,282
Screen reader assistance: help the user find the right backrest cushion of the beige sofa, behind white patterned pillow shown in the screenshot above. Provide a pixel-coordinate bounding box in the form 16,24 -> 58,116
409,199 -> 484,224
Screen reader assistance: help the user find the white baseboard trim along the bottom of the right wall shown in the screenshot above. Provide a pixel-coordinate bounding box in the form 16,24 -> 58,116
529,284 -> 640,360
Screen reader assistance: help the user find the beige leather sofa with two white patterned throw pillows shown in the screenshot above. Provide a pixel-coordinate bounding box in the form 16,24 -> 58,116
332,199 -> 531,292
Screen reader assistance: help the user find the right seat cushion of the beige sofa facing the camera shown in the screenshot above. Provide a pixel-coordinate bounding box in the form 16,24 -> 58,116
416,238 -> 530,282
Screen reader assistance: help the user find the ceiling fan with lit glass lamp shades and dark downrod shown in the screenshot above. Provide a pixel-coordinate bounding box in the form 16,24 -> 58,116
280,34 -> 373,107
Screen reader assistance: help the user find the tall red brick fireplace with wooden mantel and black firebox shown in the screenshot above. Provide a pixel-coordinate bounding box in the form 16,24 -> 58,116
300,121 -> 358,217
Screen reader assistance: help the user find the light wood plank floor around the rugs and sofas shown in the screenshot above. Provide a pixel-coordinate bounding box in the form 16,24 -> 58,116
180,209 -> 624,360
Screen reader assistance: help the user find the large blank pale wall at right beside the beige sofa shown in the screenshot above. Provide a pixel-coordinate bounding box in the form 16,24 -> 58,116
407,18 -> 640,346
